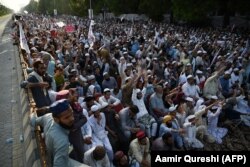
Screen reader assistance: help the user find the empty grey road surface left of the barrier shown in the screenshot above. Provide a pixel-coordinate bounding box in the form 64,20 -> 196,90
0,15 -> 24,167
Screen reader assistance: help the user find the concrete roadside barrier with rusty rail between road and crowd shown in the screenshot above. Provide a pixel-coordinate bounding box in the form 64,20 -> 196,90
17,47 -> 48,167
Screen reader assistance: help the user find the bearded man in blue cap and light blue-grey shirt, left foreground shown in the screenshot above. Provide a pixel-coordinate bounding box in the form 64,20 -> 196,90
31,99 -> 88,167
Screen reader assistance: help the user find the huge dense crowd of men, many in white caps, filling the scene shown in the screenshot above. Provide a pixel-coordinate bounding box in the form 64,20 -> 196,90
13,14 -> 250,167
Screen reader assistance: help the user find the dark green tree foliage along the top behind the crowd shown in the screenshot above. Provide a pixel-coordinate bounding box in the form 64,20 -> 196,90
23,0 -> 250,23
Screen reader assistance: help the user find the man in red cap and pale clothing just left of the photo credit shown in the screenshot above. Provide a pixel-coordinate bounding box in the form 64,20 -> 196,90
128,131 -> 151,167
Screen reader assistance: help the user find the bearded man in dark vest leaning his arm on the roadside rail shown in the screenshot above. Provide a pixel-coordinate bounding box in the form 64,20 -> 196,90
21,60 -> 51,116
